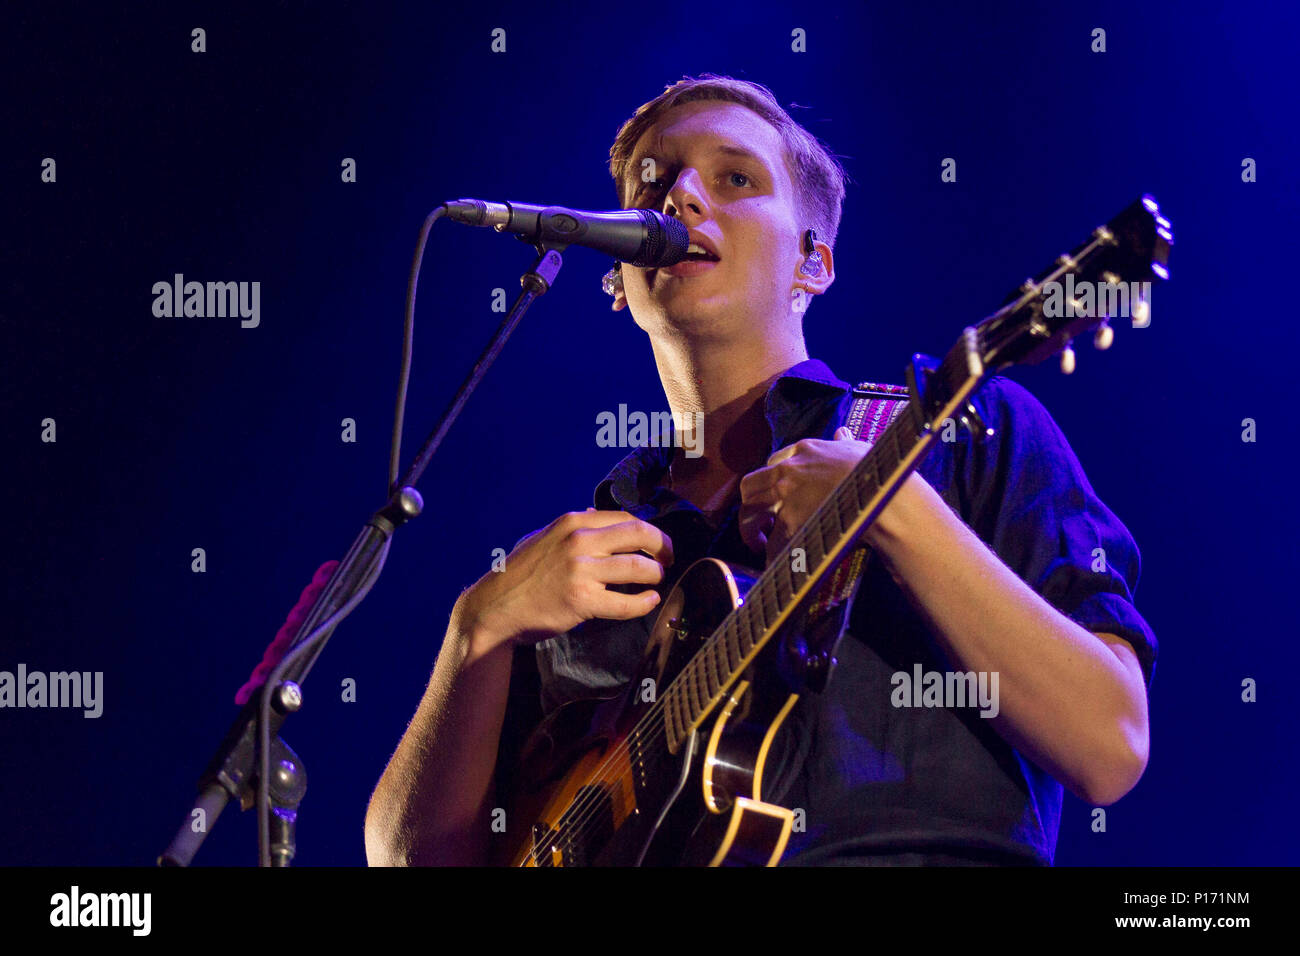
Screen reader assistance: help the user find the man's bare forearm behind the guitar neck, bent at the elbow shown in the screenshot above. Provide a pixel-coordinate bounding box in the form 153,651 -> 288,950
872,475 -> 1148,804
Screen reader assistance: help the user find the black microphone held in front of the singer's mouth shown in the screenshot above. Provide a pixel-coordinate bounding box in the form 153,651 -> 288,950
442,199 -> 690,269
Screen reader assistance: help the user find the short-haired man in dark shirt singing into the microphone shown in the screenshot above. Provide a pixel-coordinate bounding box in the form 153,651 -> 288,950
365,74 -> 1157,865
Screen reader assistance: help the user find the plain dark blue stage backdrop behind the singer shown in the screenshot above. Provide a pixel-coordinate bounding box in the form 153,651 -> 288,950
0,3 -> 1300,865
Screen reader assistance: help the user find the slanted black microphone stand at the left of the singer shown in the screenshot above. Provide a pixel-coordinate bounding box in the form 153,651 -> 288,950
157,238 -> 568,866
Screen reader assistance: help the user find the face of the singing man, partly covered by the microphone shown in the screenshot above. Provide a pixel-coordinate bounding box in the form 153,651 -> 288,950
623,101 -> 802,341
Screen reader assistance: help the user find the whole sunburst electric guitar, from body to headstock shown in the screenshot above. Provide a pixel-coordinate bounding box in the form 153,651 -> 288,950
498,196 -> 1174,866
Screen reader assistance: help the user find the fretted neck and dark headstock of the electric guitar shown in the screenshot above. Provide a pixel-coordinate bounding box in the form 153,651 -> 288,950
658,195 -> 1174,753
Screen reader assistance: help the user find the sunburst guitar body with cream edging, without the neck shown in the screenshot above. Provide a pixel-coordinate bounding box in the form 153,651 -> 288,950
507,558 -> 798,866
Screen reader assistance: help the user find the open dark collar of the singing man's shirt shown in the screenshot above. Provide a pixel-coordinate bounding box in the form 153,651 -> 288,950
593,359 -> 853,516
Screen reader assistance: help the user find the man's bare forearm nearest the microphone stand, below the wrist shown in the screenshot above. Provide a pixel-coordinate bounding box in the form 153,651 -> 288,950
365,602 -> 511,865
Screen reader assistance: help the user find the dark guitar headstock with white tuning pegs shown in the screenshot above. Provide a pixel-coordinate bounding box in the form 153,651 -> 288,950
909,195 -> 1174,421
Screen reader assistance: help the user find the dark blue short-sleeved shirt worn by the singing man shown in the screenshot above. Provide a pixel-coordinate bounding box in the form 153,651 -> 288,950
498,359 -> 1157,865
